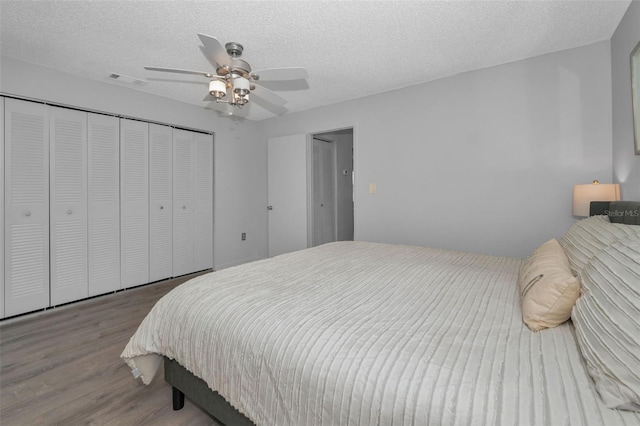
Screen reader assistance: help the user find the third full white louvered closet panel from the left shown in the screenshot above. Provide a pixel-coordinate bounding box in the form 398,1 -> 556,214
87,113 -> 121,296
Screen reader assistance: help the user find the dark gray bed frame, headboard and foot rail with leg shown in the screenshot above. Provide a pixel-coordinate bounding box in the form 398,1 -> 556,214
164,201 -> 640,426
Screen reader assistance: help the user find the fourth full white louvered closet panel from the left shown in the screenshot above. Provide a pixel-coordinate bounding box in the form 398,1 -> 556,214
120,119 -> 149,288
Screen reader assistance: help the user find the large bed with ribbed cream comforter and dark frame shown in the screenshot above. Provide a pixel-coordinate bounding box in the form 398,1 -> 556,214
122,202 -> 640,426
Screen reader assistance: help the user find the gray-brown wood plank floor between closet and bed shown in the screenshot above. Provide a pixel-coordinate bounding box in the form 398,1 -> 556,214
0,276 -> 217,426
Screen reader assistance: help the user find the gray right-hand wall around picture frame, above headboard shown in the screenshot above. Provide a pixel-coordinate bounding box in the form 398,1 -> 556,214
611,0 -> 640,200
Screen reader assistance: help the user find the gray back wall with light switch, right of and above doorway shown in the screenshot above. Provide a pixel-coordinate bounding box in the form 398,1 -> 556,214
259,41 -> 612,257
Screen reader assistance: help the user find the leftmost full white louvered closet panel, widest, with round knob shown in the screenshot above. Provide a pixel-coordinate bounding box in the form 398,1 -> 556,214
4,99 -> 49,316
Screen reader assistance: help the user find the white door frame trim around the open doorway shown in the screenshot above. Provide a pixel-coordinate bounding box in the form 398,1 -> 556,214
307,123 -> 358,247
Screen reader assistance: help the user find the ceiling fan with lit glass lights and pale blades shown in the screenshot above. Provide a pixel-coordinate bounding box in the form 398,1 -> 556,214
144,34 -> 308,114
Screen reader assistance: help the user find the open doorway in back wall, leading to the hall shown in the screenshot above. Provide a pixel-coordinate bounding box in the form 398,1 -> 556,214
308,128 -> 354,247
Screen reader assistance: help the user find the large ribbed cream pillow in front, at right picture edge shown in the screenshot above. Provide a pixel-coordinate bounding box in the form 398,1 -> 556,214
571,237 -> 640,411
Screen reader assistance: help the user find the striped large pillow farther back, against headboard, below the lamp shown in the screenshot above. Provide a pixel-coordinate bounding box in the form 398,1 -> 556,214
559,216 -> 640,275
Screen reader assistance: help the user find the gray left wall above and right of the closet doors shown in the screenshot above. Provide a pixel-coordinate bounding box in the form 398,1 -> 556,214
0,57 -> 267,268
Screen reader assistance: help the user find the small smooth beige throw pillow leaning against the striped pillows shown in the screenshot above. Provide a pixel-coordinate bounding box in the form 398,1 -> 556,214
518,239 -> 580,331
